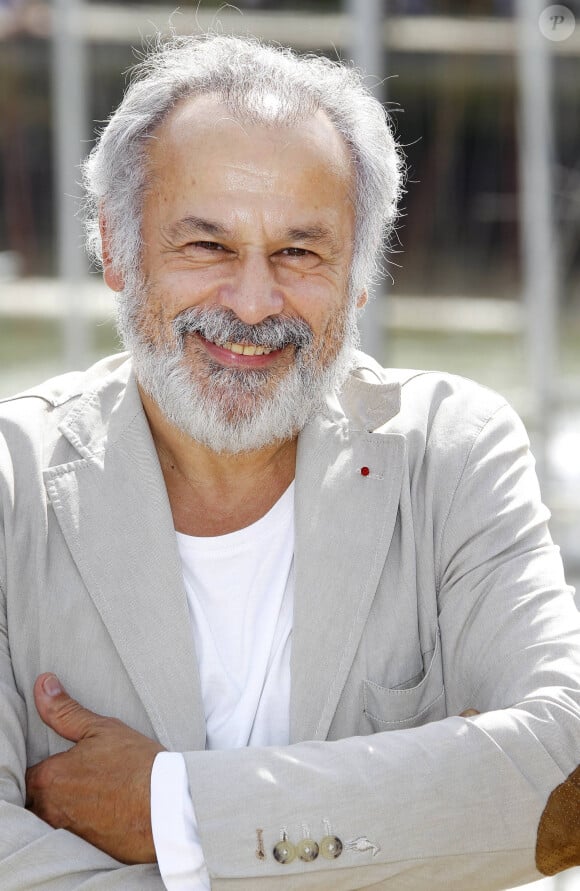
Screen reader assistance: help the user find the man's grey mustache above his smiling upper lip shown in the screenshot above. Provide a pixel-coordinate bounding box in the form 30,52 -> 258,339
173,306 -> 314,350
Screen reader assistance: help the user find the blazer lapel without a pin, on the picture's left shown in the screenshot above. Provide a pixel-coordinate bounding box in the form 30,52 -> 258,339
45,370 -> 205,751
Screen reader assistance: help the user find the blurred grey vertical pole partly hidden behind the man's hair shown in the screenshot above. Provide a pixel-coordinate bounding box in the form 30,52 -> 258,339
345,0 -> 387,361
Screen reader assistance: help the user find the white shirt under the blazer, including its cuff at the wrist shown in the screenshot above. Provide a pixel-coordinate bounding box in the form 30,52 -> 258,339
151,483 -> 294,891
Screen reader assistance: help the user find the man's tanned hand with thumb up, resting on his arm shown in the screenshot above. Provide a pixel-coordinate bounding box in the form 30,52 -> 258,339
26,674 -> 164,864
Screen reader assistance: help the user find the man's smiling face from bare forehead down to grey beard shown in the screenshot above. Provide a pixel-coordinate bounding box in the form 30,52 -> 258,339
105,97 -> 362,451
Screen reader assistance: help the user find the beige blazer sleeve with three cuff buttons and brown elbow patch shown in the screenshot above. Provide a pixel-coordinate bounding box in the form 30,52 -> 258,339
185,406 -> 580,891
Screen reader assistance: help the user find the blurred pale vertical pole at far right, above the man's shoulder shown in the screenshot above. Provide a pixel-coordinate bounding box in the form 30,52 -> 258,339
516,0 -> 558,482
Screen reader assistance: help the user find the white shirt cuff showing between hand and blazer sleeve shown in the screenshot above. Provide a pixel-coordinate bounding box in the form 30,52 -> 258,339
151,752 -> 210,891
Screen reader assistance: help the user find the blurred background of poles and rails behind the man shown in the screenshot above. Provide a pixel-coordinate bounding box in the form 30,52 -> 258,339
0,0 -> 580,889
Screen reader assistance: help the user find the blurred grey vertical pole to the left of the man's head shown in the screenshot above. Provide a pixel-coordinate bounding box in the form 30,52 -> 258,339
51,0 -> 89,368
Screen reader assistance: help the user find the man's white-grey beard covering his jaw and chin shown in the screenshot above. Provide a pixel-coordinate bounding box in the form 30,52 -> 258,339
118,288 -> 359,454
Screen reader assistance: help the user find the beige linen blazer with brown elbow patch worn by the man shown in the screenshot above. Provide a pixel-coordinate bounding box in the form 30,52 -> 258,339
0,354 -> 580,891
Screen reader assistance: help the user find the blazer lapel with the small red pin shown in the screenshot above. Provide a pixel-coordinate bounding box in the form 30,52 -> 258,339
290,387 -> 405,742
